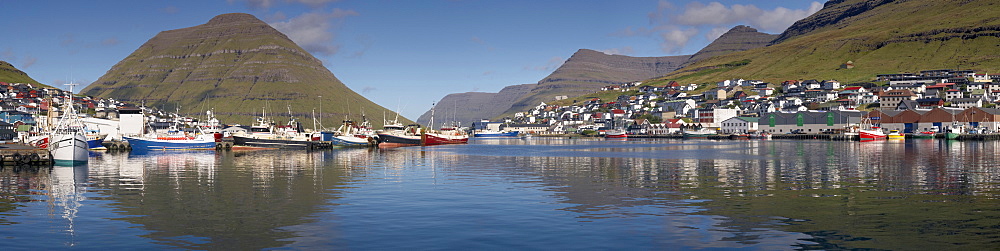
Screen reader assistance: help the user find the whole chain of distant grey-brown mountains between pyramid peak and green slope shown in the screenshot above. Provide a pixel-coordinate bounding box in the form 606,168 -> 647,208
417,25 -> 777,124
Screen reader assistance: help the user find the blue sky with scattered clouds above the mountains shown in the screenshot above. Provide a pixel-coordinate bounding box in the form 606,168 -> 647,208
0,0 -> 822,120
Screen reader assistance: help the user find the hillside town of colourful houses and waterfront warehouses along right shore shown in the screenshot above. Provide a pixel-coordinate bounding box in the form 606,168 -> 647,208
488,68 -> 1000,135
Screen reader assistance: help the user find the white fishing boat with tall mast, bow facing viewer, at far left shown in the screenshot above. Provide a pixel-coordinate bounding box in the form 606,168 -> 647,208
45,84 -> 90,165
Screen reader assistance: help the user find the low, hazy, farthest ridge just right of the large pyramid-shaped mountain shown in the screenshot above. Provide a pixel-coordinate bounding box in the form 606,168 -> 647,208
417,84 -> 535,126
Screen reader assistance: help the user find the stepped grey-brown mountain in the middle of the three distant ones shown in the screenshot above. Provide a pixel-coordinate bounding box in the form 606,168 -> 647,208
503,49 -> 691,115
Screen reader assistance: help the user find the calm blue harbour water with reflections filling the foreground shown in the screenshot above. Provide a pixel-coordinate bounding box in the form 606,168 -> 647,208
0,138 -> 1000,250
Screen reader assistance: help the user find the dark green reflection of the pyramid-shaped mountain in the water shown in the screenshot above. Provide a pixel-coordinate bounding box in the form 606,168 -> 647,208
85,151 -> 363,249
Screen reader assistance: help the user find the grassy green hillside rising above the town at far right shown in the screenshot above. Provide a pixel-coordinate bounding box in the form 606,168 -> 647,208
661,0 -> 1000,83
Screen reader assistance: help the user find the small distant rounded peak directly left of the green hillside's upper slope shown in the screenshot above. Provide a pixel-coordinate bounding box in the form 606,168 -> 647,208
685,25 -> 778,65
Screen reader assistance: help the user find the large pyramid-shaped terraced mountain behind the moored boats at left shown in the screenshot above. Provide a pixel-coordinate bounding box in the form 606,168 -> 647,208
82,13 -> 409,127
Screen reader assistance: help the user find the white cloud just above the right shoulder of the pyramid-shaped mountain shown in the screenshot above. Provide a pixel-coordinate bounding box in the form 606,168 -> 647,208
271,9 -> 359,56
